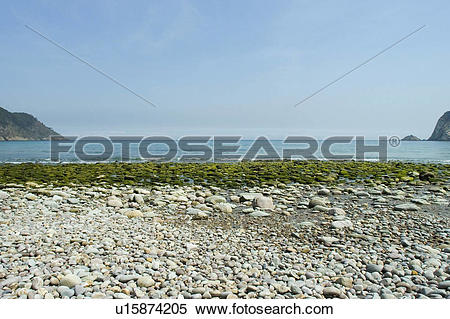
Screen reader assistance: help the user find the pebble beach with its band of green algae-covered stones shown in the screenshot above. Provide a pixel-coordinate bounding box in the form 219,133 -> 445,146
0,161 -> 450,299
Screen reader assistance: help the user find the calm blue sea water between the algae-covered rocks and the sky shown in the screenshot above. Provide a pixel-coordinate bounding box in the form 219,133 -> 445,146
0,140 -> 450,164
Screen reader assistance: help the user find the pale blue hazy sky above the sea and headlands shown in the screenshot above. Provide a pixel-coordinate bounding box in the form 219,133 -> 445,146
0,0 -> 450,138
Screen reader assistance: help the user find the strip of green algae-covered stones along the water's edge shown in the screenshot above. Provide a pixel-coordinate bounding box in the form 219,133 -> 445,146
0,161 -> 450,188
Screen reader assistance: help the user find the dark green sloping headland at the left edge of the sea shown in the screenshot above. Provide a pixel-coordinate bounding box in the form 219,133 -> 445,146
0,107 -> 60,141
